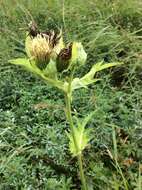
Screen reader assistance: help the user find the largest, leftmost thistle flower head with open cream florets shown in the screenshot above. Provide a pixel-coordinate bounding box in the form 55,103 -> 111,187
25,27 -> 63,69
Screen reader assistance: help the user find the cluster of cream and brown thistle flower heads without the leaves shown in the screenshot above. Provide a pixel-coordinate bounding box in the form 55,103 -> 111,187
25,23 -> 87,72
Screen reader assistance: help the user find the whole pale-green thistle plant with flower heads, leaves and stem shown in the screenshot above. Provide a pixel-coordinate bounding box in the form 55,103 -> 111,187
9,24 -> 120,190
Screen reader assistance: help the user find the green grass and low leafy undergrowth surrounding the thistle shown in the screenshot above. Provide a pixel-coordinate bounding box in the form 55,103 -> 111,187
0,0 -> 142,190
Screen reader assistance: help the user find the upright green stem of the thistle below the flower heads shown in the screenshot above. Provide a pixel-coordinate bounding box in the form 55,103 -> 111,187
65,90 -> 88,190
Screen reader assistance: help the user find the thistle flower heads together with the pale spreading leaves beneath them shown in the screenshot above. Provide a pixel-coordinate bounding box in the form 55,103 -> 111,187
9,21 -> 122,92
